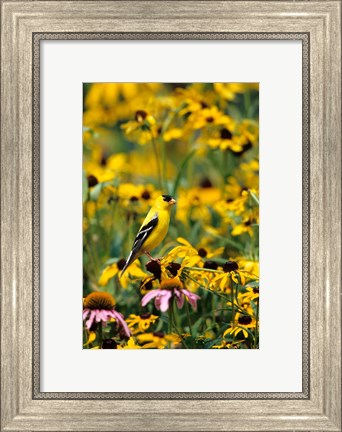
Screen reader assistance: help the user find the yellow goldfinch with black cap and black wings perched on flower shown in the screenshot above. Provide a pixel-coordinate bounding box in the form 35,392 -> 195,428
120,195 -> 176,277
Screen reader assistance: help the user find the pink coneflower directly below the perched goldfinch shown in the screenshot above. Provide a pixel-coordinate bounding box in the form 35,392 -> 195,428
141,278 -> 200,312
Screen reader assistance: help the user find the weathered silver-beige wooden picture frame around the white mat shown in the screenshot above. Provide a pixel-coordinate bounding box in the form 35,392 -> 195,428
1,0 -> 341,431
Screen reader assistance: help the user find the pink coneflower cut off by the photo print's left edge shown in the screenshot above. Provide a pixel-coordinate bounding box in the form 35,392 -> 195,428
83,292 -> 131,337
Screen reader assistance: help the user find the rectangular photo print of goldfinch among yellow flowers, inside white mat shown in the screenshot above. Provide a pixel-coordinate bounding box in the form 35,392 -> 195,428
82,82 -> 260,349
